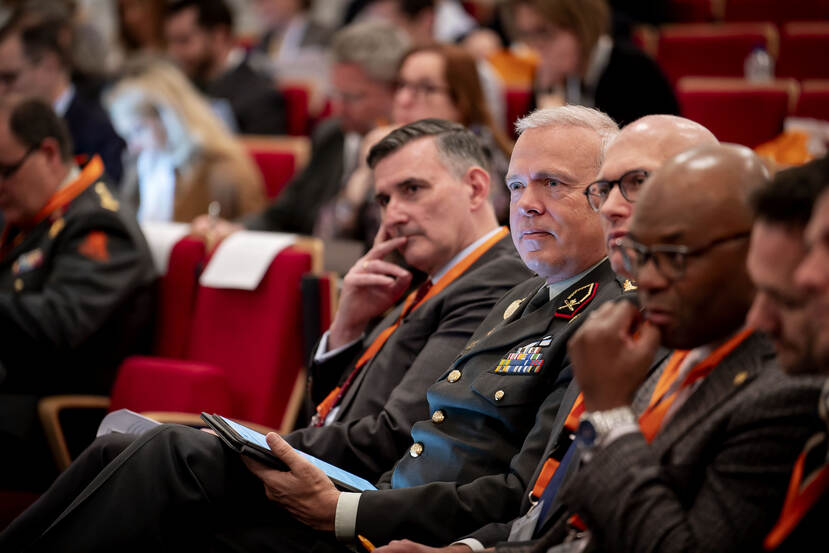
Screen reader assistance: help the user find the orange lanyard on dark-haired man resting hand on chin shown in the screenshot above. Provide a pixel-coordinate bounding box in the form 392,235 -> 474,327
314,227 -> 509,426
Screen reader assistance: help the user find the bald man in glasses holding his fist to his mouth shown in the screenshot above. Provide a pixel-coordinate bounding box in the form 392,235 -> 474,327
524,146 -> 820,552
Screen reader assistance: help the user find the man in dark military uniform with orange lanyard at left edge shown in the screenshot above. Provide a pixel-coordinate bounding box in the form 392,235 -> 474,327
0,100 -> 156,488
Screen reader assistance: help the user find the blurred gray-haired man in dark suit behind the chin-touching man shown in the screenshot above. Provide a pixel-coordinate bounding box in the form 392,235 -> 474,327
193,22 -> 407,247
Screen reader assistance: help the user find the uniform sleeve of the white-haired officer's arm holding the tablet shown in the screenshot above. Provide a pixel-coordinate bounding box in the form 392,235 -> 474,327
357,363 -> 572,546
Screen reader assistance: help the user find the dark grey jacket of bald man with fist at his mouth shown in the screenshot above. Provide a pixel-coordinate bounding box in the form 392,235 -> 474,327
562,374 -> 817,553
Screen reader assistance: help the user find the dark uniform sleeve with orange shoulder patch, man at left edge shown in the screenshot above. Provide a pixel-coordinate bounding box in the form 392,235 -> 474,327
0,212 -> 149,359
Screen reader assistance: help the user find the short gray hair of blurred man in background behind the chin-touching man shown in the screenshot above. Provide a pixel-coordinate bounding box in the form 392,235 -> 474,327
331,21 -> 409,83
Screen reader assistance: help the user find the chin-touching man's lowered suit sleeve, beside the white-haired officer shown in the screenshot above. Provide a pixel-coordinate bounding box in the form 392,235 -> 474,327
287,242 -> 525,480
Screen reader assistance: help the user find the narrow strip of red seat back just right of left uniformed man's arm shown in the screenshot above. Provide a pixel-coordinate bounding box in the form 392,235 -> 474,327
155,237 -> 205,358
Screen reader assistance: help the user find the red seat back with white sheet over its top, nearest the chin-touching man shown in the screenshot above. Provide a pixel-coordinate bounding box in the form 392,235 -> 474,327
187,248 -> 311,427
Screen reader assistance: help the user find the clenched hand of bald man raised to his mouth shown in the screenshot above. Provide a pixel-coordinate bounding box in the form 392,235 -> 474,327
567,301 -> 659,411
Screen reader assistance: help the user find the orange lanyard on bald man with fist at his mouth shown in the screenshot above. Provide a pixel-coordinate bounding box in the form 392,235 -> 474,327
639,328 -> 754,442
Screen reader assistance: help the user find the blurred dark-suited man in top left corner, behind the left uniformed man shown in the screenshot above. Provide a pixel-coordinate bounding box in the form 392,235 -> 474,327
0,18 -> 125,184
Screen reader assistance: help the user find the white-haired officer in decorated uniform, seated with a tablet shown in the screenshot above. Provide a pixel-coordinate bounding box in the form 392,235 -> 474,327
0,106 -> 622,551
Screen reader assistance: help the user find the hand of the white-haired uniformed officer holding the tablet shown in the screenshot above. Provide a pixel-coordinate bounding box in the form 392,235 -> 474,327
242,432 -> 340,532
